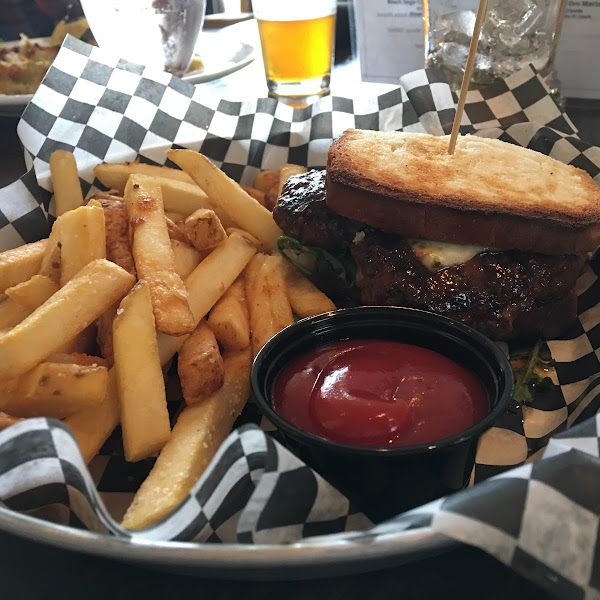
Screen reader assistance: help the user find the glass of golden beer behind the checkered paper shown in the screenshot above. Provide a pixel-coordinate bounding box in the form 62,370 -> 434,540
252,0 -> 336,102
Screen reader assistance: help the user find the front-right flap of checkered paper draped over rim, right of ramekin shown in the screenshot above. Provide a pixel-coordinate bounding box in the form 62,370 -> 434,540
370,415 -> 600,598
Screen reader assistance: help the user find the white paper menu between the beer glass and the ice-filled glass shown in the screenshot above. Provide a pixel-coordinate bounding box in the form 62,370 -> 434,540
354,0 -> 425,83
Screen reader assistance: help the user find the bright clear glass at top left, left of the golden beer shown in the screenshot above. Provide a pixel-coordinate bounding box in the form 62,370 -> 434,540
81,0 -> 206,76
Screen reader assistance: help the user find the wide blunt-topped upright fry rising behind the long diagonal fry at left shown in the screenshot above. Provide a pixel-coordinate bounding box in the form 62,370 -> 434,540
54,204 -> 106,286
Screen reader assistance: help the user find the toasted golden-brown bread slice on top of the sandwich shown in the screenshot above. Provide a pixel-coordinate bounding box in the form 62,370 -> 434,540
327,129 -> 600,254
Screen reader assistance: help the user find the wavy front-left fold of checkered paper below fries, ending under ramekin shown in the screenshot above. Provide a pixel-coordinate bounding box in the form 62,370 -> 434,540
0,418 -> 372,544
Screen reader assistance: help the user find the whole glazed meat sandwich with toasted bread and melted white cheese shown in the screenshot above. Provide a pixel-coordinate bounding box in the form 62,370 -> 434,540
273,129 -> 600,340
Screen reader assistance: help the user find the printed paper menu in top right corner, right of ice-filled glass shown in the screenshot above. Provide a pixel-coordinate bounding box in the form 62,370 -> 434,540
556,0 -> 600,100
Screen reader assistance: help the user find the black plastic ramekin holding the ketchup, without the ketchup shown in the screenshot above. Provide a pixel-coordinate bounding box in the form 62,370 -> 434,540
252,306 -> 513,522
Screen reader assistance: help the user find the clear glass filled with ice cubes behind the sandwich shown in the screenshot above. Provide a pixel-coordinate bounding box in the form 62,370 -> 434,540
423,0 -> 565,92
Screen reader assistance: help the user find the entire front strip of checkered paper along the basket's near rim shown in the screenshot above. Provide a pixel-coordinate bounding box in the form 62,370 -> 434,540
0,415 -> 600,598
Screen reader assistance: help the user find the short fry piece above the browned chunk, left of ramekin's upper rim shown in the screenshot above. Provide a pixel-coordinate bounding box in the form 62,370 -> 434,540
208,278 -> 250,350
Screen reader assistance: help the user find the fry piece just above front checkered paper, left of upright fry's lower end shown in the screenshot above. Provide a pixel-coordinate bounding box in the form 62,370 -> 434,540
64,369 -> 120,463
